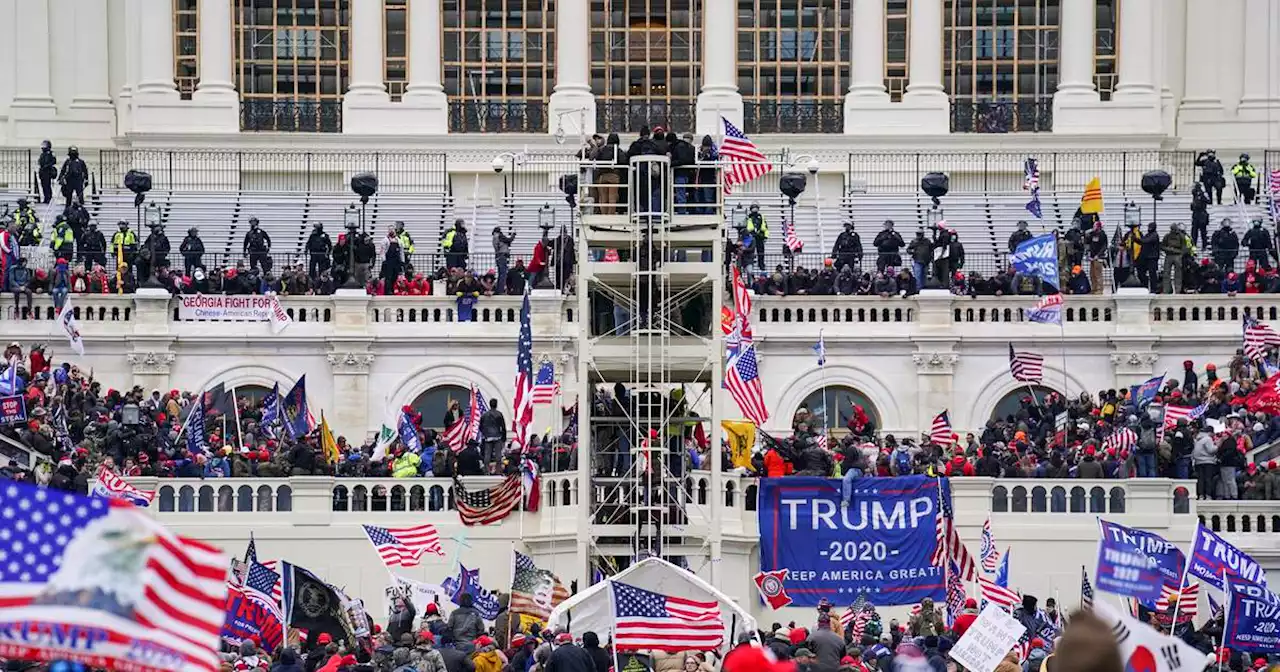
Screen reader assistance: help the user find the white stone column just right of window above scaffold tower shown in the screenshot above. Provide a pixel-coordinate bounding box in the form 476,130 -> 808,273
695,0 -> 744,136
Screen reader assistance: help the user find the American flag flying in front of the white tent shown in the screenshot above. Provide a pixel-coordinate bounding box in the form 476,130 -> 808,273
609,581 -> 724,653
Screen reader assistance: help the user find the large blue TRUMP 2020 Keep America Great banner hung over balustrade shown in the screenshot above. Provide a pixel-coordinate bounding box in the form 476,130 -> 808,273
759,476 -> 951,607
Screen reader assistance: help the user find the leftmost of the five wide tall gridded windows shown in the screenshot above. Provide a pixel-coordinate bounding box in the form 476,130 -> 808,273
233,0 -> 351,132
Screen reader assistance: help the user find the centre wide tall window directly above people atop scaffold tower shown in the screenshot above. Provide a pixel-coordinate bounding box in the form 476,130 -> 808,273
591,0 -> 701,132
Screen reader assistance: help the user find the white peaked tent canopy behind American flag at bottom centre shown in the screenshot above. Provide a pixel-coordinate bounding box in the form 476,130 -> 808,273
547,558 -> 756,646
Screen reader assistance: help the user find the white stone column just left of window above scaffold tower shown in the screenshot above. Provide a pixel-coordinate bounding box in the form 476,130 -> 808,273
547,0 -> 595,136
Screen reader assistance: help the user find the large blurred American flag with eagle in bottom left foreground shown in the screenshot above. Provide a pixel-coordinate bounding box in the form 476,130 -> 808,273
0,483 -> 229,671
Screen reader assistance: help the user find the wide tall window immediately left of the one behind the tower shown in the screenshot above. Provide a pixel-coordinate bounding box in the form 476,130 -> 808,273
443,0 -> 556,132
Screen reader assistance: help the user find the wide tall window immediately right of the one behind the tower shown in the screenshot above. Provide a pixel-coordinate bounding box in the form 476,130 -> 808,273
737,0 -> 849,133
